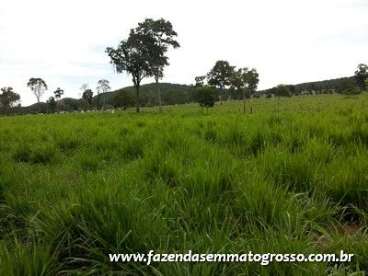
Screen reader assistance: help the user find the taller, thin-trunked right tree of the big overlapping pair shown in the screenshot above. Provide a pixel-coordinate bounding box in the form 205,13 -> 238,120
136,18 -> 180,111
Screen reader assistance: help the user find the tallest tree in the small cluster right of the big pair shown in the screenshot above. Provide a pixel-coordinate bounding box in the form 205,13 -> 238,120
207,60 -> 235,101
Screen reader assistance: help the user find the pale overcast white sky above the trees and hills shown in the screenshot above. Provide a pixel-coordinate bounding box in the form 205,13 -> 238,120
0,0 -> 368,105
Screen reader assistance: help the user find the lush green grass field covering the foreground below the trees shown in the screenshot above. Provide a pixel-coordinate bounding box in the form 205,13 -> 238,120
0,95 -> 368,275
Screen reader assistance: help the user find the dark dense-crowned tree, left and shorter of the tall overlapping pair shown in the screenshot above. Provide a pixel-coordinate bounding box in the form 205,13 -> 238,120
106,29 -> 164,112
